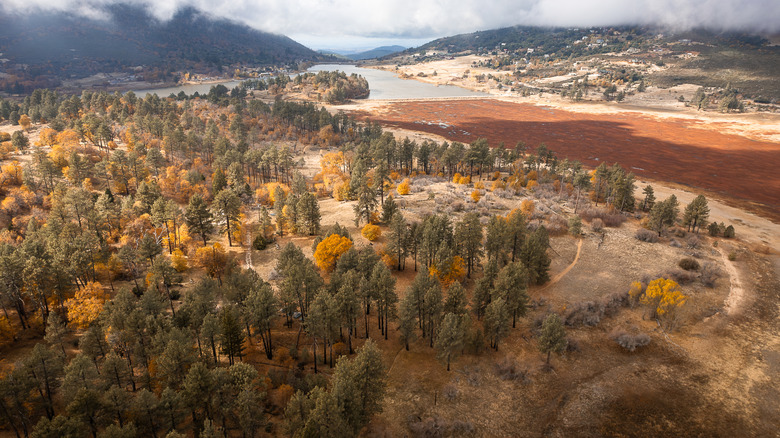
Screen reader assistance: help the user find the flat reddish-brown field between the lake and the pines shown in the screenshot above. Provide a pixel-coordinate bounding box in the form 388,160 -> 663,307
359,99 -> 780,219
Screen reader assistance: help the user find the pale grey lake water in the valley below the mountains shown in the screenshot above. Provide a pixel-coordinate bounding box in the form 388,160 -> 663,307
133,64 -> 488,100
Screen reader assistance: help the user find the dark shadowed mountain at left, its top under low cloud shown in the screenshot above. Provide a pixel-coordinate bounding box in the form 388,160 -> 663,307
0,4 -> 326,87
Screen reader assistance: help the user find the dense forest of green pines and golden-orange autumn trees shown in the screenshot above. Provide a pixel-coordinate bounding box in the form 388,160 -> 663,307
0,84 -> 733,437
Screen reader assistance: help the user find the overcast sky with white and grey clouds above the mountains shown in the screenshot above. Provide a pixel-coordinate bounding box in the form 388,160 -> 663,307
2,0 -> 780,49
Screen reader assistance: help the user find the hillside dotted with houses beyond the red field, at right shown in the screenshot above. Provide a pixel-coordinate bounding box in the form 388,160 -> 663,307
404,26 -> 780,103
